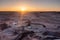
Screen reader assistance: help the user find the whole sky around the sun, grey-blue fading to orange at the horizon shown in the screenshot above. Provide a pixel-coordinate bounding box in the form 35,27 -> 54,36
0,0 -> 60,11
